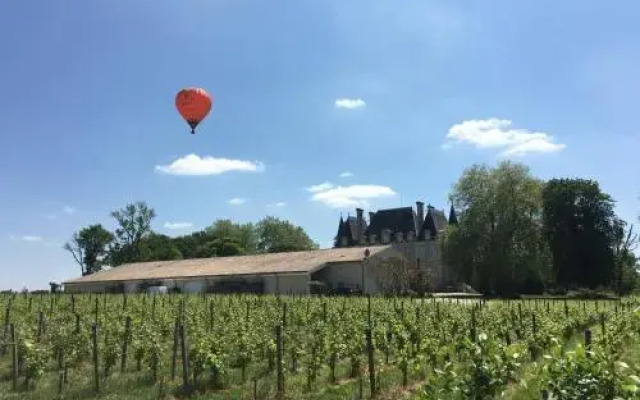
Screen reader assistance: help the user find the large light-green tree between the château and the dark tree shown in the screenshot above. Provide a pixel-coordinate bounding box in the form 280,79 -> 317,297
443,161 -> 550,295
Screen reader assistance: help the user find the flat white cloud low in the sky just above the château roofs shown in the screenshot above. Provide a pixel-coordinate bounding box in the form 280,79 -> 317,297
307,182 -> 396,208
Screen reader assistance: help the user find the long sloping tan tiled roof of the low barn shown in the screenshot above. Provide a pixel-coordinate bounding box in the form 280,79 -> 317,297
64,245 -> 399,284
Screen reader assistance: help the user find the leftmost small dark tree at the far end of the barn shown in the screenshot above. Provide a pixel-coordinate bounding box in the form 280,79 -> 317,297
64,224 -> 114,275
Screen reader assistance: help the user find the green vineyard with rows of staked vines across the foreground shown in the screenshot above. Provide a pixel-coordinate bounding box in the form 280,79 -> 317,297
0,294 -> 640,400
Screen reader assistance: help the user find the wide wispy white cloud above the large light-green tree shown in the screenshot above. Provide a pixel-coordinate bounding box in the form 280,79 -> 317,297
442,118 -> 566,156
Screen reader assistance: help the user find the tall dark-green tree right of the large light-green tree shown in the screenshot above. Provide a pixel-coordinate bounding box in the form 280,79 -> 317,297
543,179 -> 618,288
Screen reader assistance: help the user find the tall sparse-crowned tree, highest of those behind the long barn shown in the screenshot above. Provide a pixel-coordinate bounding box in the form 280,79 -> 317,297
110,201 -> 156,266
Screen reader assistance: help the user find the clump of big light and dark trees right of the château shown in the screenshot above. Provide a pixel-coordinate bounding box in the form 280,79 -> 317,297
441,161 -> 640,295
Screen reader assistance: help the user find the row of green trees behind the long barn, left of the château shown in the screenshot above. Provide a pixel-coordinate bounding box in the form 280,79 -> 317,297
64,201 -> 318,275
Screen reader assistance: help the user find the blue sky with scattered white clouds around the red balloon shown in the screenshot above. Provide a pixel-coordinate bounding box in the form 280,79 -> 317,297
0,0 -> 640,289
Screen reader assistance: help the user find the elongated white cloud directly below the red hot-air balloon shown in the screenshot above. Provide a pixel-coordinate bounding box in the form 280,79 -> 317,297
155,154 -> 264,176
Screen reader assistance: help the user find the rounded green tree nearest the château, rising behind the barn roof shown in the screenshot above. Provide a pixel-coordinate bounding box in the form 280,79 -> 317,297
256,216 -> 318,253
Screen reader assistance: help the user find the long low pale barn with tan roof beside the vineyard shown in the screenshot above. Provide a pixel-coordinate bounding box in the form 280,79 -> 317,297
64,245 -> 407,294
